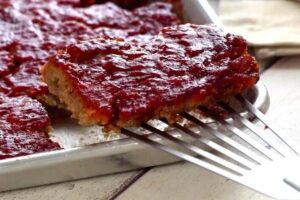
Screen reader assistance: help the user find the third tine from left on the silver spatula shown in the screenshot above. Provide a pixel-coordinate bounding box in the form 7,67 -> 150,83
162,120 -> 254,169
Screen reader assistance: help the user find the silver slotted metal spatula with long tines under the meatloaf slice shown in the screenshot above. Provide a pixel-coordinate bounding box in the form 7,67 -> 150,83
122,95 -> 300,199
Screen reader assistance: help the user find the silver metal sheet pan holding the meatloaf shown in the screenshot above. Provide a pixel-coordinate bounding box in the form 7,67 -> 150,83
0,0 -> 269,191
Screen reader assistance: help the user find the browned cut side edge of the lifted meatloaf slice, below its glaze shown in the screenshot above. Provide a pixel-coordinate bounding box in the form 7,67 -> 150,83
42,53 -> 258,131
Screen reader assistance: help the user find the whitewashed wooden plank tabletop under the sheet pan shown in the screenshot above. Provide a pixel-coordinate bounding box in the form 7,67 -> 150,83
0,1 -> 300,200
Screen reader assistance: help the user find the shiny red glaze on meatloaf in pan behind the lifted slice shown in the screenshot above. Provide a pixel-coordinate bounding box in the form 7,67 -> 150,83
0,0 -> 178,97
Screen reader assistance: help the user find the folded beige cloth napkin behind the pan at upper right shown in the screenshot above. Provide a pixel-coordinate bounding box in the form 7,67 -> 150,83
219,0 -> 300,59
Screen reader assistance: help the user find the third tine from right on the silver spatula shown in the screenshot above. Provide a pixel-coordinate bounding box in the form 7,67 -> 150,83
199,107 -> 274,160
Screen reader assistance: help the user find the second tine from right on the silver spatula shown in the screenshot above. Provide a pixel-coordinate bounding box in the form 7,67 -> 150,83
218,102 -> 286,157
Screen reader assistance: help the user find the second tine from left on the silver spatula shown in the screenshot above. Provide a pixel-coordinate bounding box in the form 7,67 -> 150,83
142,123 -> 245,175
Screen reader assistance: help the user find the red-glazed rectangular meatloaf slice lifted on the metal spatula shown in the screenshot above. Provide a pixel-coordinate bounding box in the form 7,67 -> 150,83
42,24 -> 258,130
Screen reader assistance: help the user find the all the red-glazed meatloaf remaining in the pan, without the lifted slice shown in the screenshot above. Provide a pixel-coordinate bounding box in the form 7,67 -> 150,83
0,0 -> 179,159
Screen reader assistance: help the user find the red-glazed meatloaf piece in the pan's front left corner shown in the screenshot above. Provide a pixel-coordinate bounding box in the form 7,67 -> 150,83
0,93 -> 59,159
